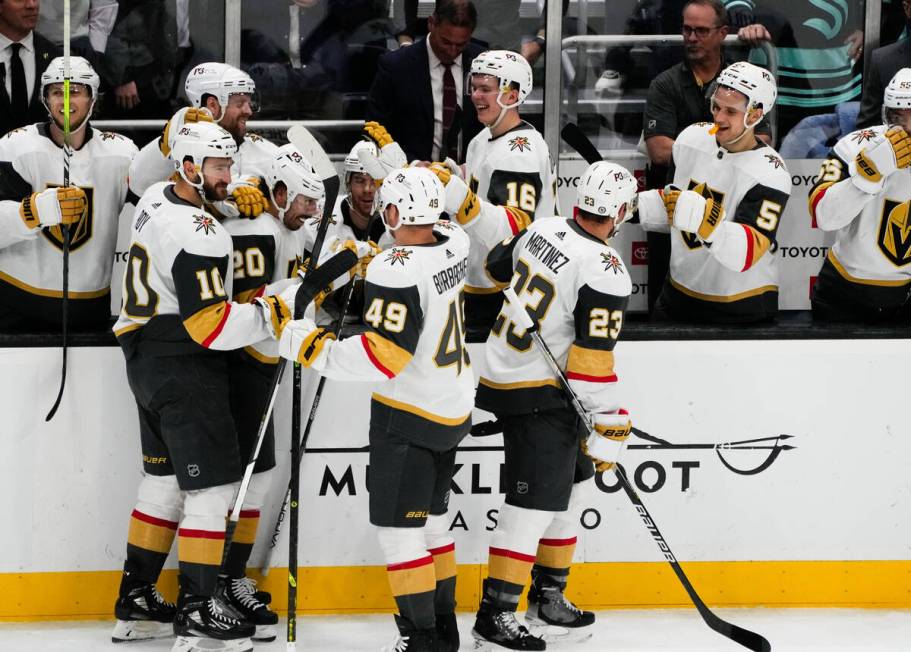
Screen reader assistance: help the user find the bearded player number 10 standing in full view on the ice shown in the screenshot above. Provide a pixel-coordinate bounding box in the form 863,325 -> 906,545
113,122 -> 294,652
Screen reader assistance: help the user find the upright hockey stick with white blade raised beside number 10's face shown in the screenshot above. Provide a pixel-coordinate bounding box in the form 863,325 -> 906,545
287,125 -> 341,650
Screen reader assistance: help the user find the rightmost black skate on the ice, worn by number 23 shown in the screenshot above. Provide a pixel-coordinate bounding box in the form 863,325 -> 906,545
525,575 -> 595,643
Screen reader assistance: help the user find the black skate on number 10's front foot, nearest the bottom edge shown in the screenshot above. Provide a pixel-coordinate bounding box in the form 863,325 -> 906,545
171,595 -> 256,652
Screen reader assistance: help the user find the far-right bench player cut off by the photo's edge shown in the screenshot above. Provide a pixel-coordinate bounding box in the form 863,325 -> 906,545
809,68 -> 911,321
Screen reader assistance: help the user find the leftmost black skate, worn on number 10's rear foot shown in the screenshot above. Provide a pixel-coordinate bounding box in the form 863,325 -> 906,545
111,580 -> 177,643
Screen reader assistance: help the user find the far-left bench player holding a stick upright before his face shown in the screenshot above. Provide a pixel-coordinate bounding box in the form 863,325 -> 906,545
0,57 -> 136,332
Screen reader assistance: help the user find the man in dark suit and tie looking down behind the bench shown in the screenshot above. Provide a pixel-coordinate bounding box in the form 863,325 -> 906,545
367,0 -> 483,162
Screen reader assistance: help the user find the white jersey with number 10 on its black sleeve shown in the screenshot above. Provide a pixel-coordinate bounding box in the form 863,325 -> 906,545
114,183 -> 270,358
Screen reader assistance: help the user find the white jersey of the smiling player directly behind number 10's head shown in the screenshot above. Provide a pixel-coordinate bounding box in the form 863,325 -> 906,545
130,133 -> 278,196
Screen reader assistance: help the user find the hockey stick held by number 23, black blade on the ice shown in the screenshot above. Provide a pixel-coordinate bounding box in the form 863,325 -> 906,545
503,286 -> 772,652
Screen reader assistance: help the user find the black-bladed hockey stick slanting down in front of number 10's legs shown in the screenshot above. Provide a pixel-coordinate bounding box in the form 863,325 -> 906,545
222,249 -> 357,560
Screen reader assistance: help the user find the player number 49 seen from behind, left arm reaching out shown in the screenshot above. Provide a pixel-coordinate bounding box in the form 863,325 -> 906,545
279,167 -> 474,652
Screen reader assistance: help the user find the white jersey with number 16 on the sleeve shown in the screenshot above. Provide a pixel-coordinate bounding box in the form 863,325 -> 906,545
459,122 -> 557,294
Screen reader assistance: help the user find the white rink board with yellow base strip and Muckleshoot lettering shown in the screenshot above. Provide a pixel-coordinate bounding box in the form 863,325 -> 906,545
0,340 -> 911,618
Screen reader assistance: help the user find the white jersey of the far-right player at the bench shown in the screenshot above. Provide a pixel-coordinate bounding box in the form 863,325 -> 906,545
808,125 -> 911,307
